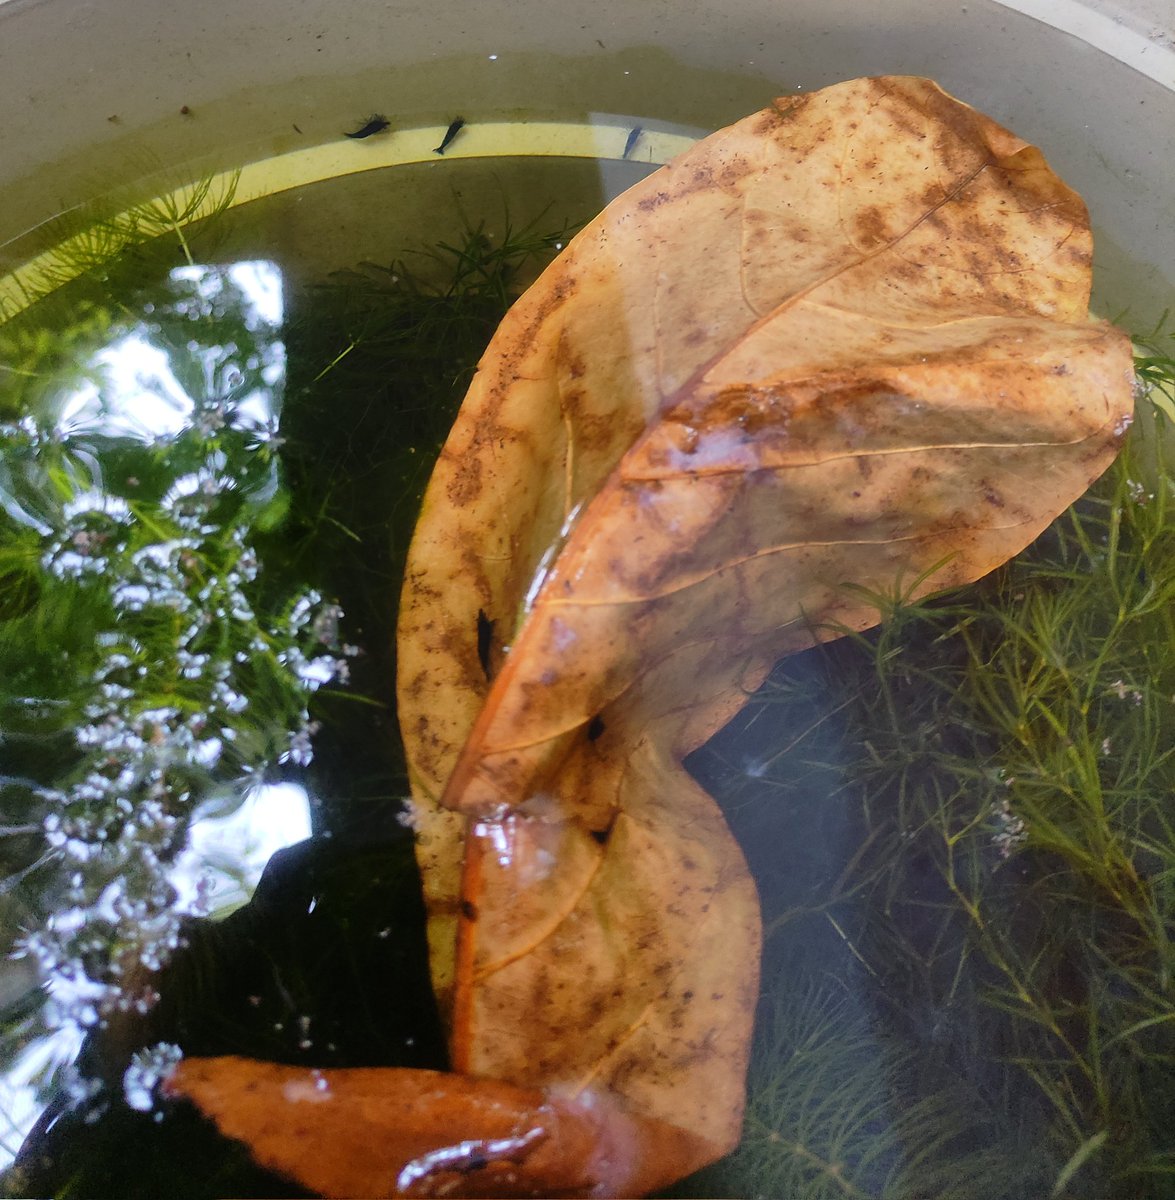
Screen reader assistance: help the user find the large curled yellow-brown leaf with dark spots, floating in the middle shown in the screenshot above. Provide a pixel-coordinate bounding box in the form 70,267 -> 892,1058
170,78 -> 1132,1194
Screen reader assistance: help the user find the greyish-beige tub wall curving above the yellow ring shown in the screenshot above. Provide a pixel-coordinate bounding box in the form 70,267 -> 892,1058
0,0 -> 1175,328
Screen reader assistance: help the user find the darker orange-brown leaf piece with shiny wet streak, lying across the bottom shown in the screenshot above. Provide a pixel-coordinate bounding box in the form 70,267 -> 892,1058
166,1057 -> 700,1198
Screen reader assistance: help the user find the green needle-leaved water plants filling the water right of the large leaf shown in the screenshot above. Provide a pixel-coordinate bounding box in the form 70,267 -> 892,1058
693,353 -> 1175,1196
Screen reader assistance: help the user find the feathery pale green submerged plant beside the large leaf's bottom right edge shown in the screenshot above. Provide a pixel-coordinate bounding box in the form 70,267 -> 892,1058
673,967 -> 1024,1200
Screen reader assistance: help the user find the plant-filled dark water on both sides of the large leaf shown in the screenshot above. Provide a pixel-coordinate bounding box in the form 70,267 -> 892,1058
0,131 -> 1175,1196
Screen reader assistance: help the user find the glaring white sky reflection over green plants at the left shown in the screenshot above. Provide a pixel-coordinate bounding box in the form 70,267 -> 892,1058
0,253 -> 356,1160
